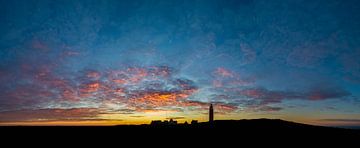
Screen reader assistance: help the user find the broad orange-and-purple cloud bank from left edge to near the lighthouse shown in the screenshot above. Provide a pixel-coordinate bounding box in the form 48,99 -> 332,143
0,66 -> 202,114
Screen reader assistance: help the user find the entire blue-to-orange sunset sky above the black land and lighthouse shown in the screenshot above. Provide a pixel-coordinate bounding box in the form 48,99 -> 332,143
0,0 -> 360,126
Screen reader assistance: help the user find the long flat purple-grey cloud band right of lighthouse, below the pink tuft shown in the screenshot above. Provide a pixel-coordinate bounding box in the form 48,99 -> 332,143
207,84 -> 351,111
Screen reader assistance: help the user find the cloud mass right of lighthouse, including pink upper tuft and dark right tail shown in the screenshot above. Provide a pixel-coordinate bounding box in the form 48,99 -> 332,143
204,67 -> 351,111
